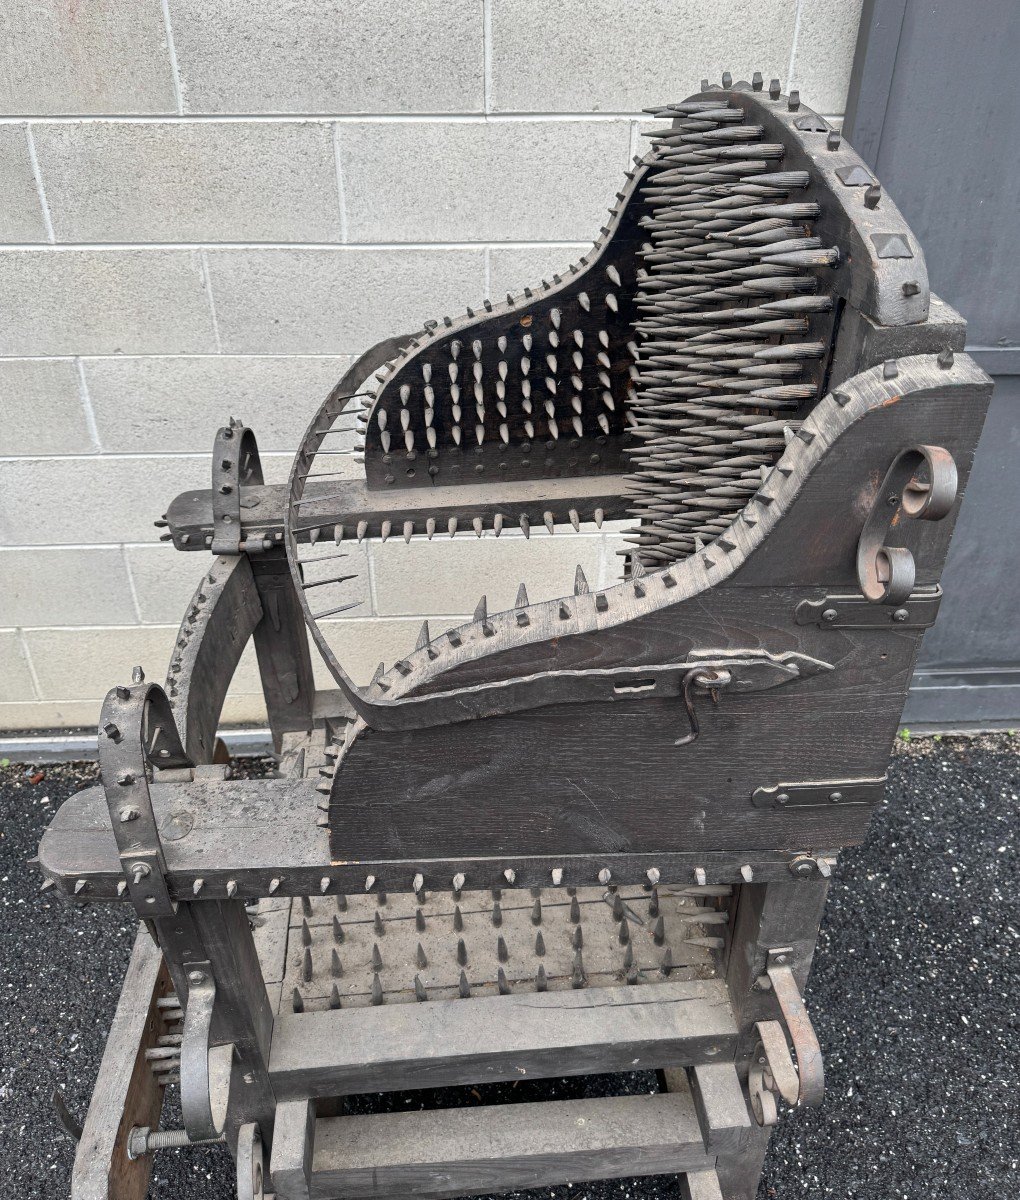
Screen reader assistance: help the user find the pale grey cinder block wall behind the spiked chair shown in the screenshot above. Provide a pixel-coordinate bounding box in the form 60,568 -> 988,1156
0,0 -> 860,730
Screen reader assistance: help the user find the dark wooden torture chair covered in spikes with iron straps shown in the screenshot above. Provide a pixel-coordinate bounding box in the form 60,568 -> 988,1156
40,76 -> 990,1200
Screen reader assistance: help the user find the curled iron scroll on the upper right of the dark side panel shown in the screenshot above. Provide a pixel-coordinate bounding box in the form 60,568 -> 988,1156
857,445 -> 958,605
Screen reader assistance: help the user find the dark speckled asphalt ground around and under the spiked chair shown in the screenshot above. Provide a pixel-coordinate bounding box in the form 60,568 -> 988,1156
0,736 -> 1020,1200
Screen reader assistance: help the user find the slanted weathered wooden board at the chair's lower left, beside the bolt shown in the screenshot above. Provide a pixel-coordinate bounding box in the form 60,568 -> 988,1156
71,926 -> 170,1200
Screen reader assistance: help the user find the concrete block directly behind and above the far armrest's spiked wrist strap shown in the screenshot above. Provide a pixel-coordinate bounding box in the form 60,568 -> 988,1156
83,355 -> 354,454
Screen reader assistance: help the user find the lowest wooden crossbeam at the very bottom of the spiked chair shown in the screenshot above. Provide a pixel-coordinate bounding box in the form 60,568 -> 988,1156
280,1094 -> 714,1200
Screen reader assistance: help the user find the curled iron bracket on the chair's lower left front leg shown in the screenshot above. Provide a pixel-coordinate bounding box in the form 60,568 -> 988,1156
181,962 -> 234,1141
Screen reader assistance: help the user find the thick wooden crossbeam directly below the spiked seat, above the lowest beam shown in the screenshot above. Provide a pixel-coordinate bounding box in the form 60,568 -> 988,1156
270,979 -> 737,1098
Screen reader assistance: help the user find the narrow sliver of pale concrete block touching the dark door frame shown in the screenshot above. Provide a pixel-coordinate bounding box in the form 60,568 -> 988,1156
790,0 -> 862,115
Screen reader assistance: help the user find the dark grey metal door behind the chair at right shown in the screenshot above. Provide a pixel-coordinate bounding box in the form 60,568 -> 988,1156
844,0 -> 1020,724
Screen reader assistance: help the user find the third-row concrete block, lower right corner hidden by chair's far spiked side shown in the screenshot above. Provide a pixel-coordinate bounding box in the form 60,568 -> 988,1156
209,248 -> 485,354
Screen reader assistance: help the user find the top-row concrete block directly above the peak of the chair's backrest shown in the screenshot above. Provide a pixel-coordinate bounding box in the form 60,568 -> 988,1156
491,0 -> 797,113
